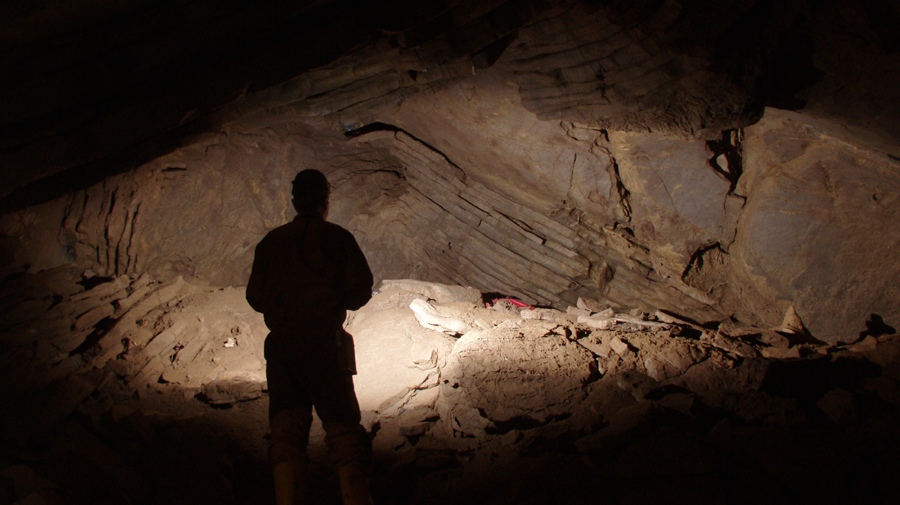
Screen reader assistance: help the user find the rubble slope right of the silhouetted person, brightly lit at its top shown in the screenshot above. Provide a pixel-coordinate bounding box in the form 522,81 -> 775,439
348,280 -> 900,503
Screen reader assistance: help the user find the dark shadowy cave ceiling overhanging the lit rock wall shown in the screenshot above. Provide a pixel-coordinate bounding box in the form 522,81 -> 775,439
0,0 -> 900,209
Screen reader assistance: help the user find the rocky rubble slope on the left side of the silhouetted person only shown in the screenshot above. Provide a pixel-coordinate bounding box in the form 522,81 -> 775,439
0,267 -> 266,505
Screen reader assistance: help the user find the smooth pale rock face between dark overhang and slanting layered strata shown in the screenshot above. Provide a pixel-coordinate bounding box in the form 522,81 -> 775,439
381,70 -> 618,221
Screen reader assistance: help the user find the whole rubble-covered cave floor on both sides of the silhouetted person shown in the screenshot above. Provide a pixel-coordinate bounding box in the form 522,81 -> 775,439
0,268 -> 900,505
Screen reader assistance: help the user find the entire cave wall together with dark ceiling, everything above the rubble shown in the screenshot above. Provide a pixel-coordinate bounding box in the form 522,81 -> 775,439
0,0 -> 900,341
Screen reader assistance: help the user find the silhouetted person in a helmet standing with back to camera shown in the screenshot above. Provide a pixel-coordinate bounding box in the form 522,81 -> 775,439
247,170 -> 373,505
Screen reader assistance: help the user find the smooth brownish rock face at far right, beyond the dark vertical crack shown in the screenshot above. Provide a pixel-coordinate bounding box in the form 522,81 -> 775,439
730,109 -> 900,342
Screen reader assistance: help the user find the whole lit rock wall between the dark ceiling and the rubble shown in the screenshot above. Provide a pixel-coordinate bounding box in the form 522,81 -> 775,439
2,100 -> 900,342
